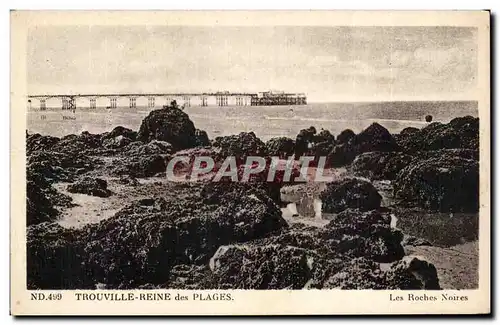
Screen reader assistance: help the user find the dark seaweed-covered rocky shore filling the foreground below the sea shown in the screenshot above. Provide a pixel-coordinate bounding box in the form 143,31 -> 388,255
26,101 -> 479,289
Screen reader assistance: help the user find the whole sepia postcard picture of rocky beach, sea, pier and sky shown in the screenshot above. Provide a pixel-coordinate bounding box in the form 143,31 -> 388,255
9,12 -> 490,312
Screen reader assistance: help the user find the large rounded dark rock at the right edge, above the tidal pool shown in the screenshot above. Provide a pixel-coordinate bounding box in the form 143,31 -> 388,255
394,156 -> 479,212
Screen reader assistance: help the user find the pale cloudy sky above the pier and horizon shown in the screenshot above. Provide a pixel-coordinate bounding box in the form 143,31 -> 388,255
27,26 -> 477,102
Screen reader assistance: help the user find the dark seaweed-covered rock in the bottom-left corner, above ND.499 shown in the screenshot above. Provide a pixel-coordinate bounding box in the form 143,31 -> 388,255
26,222 -> 96,290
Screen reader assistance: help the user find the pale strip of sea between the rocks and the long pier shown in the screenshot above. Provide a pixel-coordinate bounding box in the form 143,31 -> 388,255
27,101 -> 478,141
